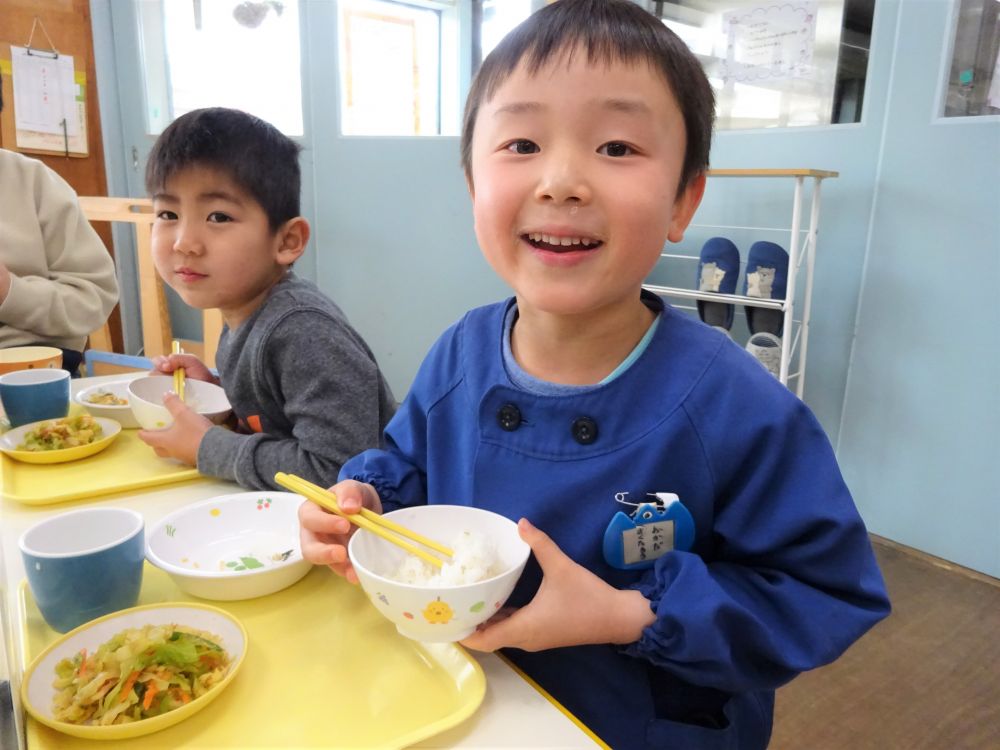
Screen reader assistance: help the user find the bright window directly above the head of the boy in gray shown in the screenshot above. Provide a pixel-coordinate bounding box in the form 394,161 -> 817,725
136,0 -> 303,135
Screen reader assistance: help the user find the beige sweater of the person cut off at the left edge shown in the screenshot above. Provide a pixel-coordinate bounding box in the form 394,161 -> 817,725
0,150 -> 118,350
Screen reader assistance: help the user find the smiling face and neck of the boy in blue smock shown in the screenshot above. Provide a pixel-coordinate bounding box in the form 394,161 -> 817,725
466,33 -> 705,384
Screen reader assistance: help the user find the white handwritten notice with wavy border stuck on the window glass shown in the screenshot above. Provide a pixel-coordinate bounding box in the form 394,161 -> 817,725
722,0 -> 818,83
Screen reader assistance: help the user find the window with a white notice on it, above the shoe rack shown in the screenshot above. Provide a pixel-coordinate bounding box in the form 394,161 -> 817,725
652,0 -> 874,130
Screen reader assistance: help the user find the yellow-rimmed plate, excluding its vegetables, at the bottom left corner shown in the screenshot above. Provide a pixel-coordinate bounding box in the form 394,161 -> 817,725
21,602 -> 247,740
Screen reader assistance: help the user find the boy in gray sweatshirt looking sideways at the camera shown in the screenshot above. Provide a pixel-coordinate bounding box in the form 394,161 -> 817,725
139,108 -> 396,489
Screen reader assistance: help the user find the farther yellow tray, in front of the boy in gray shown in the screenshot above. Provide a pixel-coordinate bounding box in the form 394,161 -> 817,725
0,430 -> 201,505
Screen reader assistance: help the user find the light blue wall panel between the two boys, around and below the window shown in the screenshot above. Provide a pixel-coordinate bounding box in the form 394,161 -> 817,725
306,3 -> 510,398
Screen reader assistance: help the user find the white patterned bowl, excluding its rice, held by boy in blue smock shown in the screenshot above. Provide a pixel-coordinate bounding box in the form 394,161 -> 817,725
347,505 -> 531,642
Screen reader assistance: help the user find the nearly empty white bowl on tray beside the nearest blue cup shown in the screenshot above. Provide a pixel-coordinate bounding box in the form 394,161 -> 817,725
146,492 -> 312,601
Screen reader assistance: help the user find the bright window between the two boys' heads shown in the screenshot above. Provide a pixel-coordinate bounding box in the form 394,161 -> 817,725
339,0 -> 459,135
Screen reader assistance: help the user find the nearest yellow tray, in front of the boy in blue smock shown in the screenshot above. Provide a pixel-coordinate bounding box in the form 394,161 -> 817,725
18,563 -> 486,750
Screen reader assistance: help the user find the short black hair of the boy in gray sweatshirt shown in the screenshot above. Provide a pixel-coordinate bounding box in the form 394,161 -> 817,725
146,107 -> 302,232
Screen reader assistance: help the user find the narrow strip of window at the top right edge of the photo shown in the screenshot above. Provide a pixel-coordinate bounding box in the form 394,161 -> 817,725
944,0 -> 1000,117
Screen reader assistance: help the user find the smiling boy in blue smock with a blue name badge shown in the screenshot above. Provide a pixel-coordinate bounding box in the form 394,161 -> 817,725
300,0 -> 889,750
